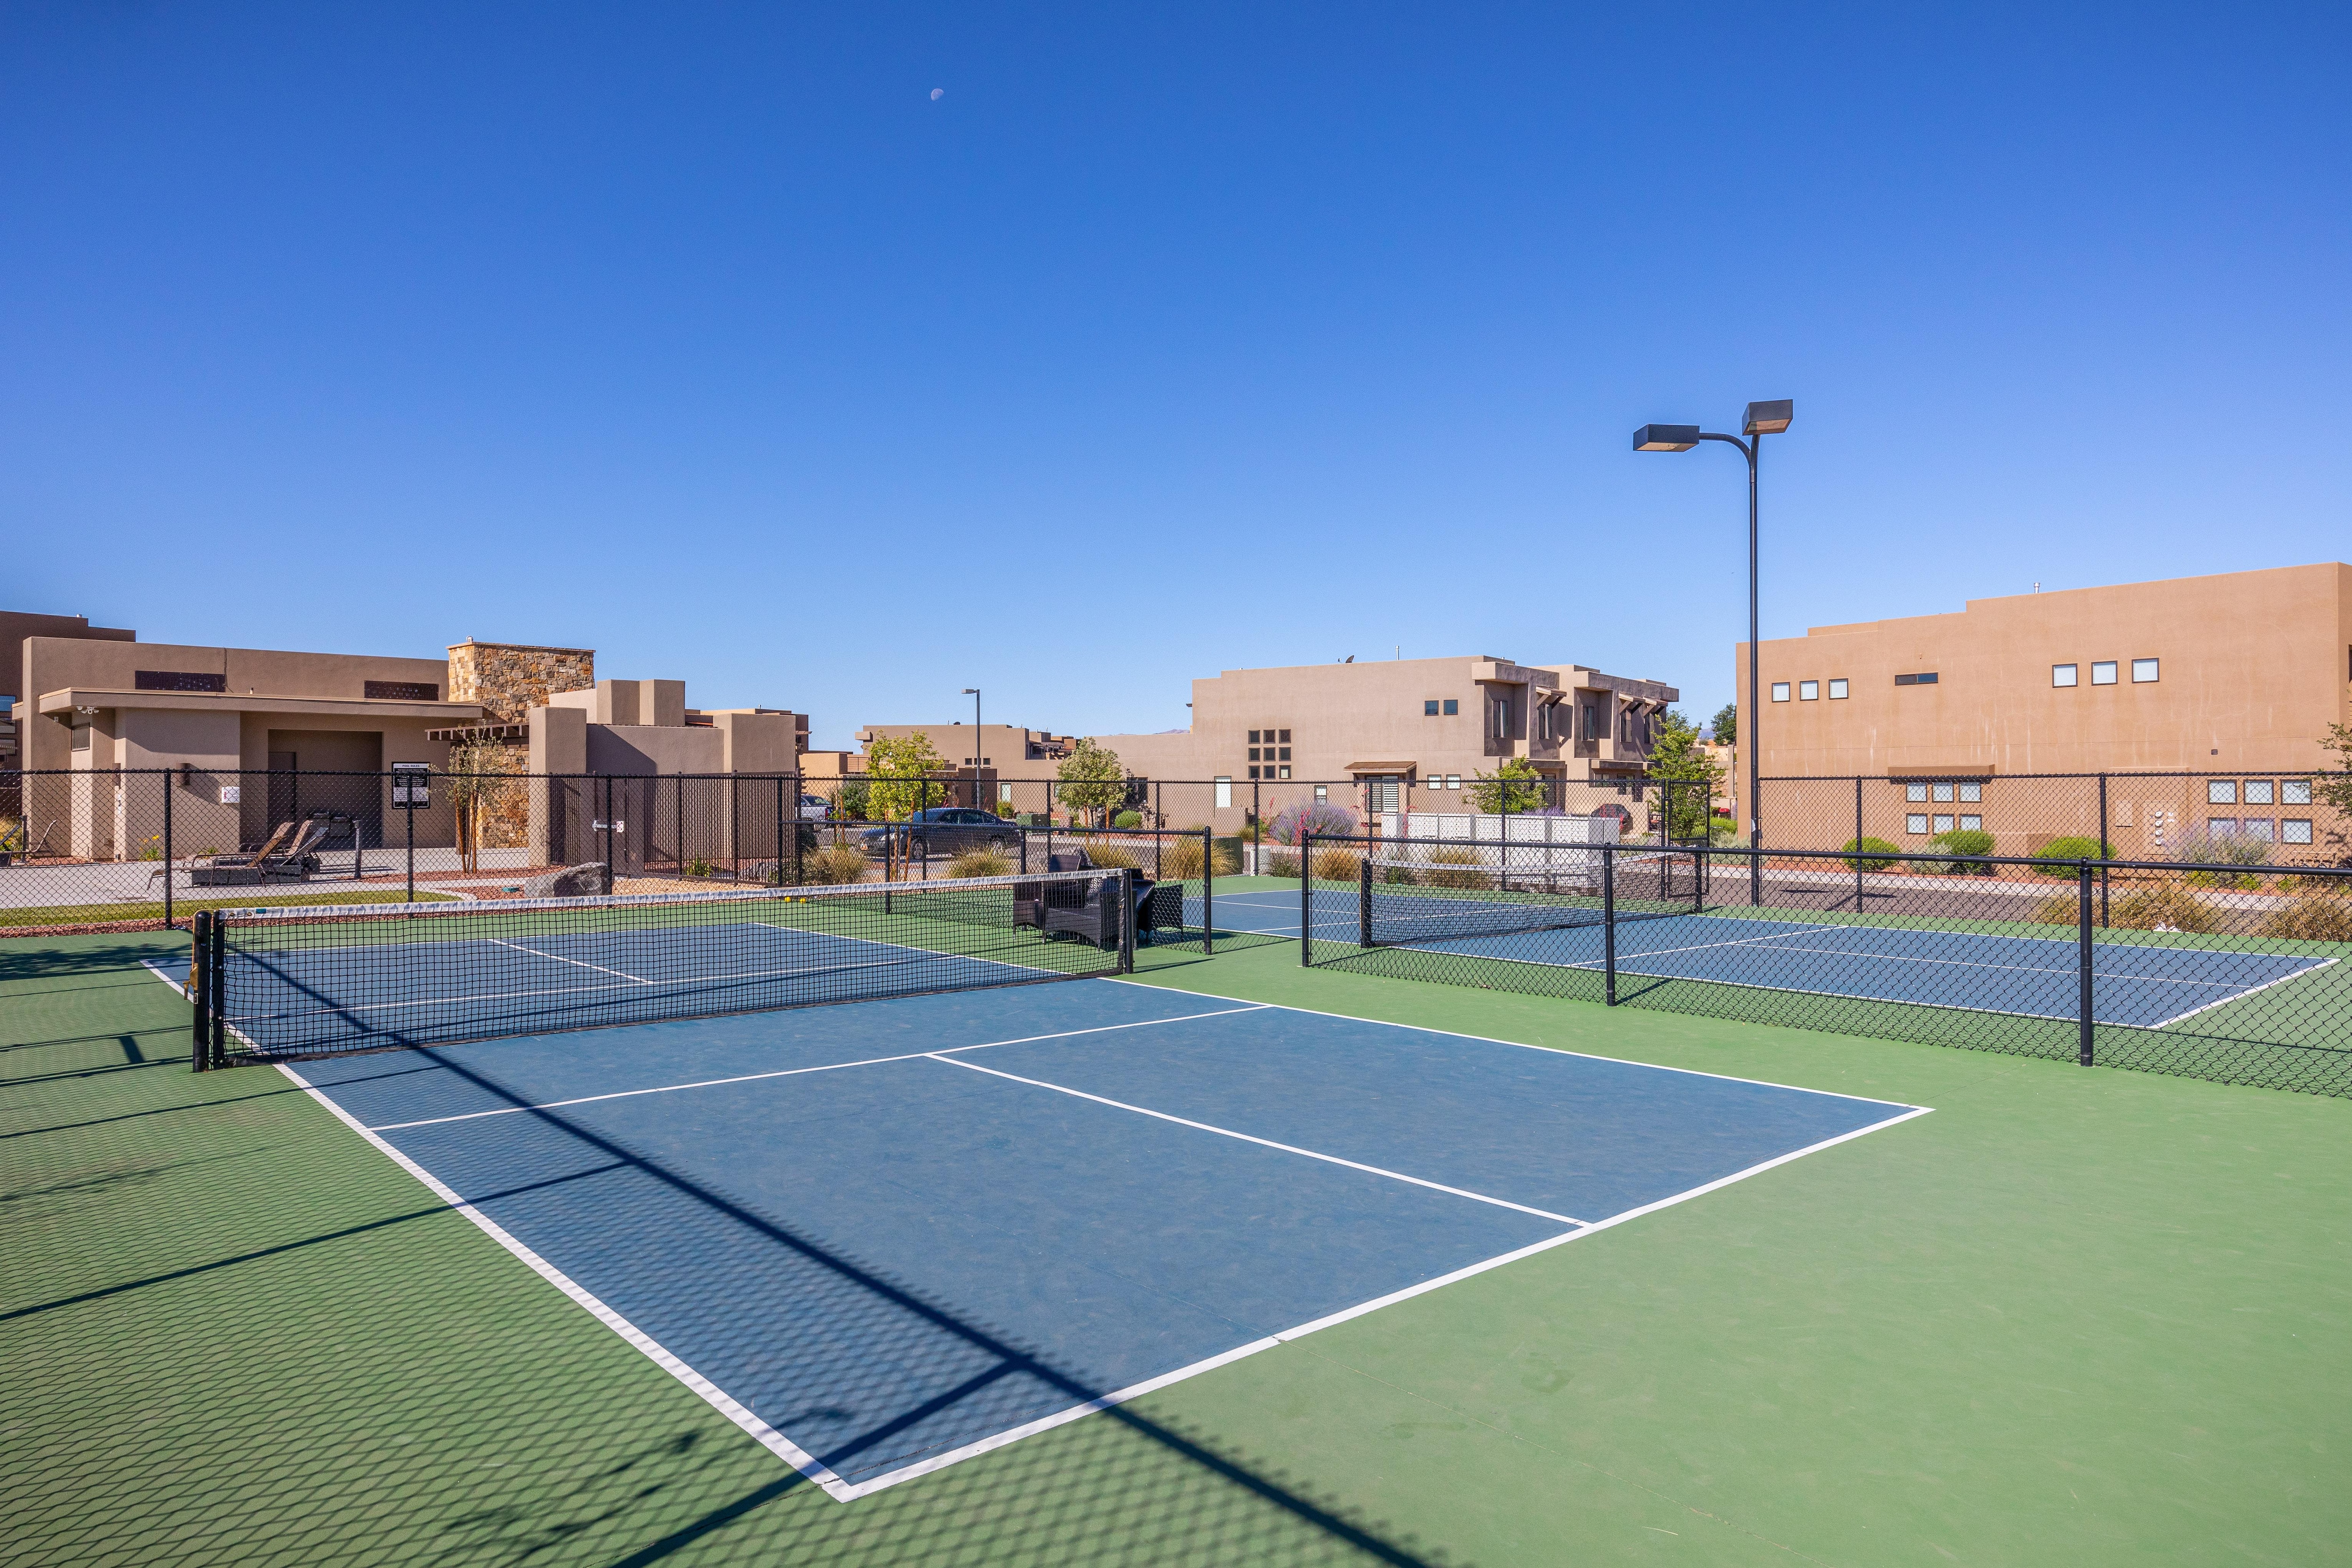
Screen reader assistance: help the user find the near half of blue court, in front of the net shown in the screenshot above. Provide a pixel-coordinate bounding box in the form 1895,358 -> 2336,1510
234,980 -> 1922,1500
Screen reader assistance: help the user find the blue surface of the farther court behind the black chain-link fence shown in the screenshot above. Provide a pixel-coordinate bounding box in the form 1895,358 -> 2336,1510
1216,891 -> 2336,1030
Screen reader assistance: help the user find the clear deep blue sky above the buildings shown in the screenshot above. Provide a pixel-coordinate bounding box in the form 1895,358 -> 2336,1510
0,2 -> 2352,745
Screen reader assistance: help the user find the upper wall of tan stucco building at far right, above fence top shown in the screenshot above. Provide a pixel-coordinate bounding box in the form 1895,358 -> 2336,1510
1736,562 -> 2352,780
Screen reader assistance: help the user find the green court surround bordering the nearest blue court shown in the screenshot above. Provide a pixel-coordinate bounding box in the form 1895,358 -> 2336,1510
0,902 -> 2352,1568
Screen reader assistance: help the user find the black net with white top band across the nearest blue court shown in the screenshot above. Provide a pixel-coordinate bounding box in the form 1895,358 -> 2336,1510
191,870 -> 1134,1067
